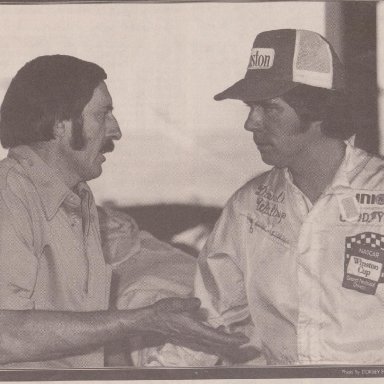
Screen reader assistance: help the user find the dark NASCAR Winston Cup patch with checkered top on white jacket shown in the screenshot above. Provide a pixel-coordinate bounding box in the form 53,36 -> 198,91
343,232 -> 384,295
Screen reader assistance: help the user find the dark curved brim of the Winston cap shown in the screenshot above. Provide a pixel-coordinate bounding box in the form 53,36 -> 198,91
214,79 -> 299,101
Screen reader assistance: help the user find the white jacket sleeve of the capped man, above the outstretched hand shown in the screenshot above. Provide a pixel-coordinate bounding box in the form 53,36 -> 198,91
194,198 -> 250,329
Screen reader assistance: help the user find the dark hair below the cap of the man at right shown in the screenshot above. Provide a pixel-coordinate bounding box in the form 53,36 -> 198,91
281,85 -> 355,140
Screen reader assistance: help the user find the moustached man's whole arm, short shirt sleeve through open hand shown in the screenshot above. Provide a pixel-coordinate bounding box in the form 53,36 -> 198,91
0,201 -> 246,364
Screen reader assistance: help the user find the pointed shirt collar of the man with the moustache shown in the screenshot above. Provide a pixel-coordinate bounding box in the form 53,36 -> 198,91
8,145 -> 89,220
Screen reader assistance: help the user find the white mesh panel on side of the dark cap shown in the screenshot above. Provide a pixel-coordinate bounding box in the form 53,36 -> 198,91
292,30 -> 333,89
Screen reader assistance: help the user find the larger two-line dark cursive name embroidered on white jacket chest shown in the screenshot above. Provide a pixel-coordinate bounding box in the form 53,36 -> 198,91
255,185 -> 287,224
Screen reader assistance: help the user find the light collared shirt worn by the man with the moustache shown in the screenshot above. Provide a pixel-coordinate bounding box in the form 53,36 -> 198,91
0,146 -> 111,368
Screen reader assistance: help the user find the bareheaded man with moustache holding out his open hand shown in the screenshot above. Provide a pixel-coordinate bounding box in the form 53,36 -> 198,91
0,55 -> 249,368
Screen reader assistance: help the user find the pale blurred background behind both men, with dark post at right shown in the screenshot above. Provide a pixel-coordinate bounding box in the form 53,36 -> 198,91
0,1 -> 384,254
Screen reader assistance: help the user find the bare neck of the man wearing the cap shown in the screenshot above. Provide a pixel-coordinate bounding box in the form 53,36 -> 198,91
289,138 -> 346,203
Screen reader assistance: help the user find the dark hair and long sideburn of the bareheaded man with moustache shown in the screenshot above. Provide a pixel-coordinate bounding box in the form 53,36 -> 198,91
0,55 -> 107,149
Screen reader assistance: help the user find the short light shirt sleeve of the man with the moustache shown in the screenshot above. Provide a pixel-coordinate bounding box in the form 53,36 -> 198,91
0,184 -> 38,310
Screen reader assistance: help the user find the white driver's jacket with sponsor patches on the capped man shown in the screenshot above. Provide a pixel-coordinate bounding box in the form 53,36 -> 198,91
195,145 -> 384,364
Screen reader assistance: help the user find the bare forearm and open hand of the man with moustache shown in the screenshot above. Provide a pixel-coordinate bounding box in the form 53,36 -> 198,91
0,298 -> 248,364
